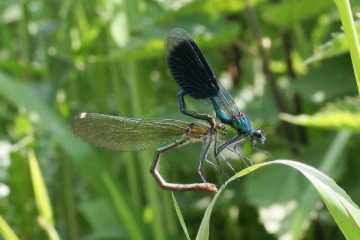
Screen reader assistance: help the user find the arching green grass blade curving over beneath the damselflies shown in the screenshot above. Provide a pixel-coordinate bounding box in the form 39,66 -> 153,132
196,160 -> 360,240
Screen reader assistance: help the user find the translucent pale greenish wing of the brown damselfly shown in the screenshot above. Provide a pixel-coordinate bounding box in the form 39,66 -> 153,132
73,113 -> 189,151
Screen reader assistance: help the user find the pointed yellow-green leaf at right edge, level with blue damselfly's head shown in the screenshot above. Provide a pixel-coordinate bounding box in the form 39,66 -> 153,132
280,97 -> 360,131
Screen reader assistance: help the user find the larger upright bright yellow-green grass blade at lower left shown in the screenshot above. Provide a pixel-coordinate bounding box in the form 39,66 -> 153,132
28,151 -> 60,240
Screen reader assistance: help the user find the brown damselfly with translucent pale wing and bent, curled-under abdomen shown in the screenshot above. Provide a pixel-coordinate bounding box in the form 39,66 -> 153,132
73,113 -> 225,192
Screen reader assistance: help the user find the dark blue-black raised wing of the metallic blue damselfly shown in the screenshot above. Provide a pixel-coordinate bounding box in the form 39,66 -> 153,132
166,28 -> 219,99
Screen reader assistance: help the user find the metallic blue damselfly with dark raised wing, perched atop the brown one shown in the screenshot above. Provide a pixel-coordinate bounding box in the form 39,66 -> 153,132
166,28 -> 266,154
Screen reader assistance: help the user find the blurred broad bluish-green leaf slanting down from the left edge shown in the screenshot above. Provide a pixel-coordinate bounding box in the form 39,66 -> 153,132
0,72 -> 107,195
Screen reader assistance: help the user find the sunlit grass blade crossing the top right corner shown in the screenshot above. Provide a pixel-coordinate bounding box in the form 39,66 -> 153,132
334,0 -> 360,93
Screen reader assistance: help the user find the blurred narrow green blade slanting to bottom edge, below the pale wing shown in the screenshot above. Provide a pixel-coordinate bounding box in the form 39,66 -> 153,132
103,174 -> 145,240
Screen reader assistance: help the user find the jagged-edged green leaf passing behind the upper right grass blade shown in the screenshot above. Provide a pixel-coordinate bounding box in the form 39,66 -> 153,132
305,22 -> 360,64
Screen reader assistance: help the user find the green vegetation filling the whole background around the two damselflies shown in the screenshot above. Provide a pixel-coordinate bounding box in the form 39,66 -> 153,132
0,0 -> 360,240
